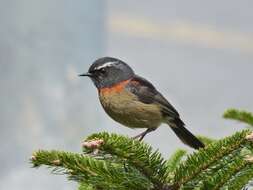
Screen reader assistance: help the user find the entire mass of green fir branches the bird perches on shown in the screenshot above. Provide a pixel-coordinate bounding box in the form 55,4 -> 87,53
31,108 -> 253,190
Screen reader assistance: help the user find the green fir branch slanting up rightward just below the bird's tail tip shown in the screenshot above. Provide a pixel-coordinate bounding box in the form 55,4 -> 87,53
174,130 -> 252,187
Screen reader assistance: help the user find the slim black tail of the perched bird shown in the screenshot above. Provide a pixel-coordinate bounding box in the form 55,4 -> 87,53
168,118 -> 205,149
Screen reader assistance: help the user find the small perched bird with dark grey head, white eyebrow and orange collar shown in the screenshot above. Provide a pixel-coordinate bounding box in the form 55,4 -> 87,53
79,57 -> 204,149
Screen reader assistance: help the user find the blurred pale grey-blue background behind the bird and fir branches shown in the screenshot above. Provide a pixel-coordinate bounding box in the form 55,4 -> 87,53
0,0 -> 253,190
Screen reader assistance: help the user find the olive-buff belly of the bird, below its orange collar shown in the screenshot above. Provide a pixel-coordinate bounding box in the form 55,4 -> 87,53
99,90 -> 162,128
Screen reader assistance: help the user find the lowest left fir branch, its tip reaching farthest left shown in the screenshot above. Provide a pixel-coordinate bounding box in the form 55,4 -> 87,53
31,150 -> 152,190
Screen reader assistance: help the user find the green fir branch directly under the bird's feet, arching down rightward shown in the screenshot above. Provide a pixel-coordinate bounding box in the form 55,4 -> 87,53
84,132 -> 167,189
